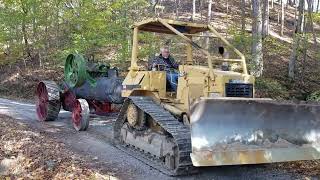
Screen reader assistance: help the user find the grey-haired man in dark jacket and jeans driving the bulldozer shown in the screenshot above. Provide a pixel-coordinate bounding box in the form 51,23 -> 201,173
149,47 -> 179,91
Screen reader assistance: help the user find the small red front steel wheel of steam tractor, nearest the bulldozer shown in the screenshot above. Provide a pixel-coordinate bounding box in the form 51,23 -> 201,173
72,99 -> 90,131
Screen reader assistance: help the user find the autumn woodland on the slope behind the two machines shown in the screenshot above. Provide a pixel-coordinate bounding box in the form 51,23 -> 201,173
0,0 -> 320,100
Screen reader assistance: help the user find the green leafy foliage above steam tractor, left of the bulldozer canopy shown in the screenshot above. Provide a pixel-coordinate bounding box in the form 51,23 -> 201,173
0,0 -> 148,65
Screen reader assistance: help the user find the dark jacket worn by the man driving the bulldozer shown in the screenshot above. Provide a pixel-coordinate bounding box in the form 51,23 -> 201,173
149,54 -> 179,71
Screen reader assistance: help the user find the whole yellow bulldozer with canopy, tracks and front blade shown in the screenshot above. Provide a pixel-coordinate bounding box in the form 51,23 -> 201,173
114,18 -> 320,175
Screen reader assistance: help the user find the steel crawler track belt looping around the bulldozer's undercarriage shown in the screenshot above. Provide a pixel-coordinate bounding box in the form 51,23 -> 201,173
114,96 -> 196,176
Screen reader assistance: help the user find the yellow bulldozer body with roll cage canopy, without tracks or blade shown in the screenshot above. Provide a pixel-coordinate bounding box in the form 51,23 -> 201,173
122,18 -> 254,115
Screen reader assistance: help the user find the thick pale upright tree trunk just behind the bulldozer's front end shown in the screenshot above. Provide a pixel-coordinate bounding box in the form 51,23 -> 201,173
252,0 -> 263,77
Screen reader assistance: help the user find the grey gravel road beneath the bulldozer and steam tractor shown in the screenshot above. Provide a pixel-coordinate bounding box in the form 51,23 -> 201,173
0,98 -> 307,180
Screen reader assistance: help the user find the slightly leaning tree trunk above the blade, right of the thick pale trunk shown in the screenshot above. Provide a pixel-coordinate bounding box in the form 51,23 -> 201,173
288,0 -> 304,79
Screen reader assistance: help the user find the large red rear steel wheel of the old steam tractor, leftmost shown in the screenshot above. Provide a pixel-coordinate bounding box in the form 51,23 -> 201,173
36,81 -> 61,121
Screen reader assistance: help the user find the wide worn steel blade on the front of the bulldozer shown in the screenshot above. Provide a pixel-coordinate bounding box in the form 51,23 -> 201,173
191,98 -> 320,166
